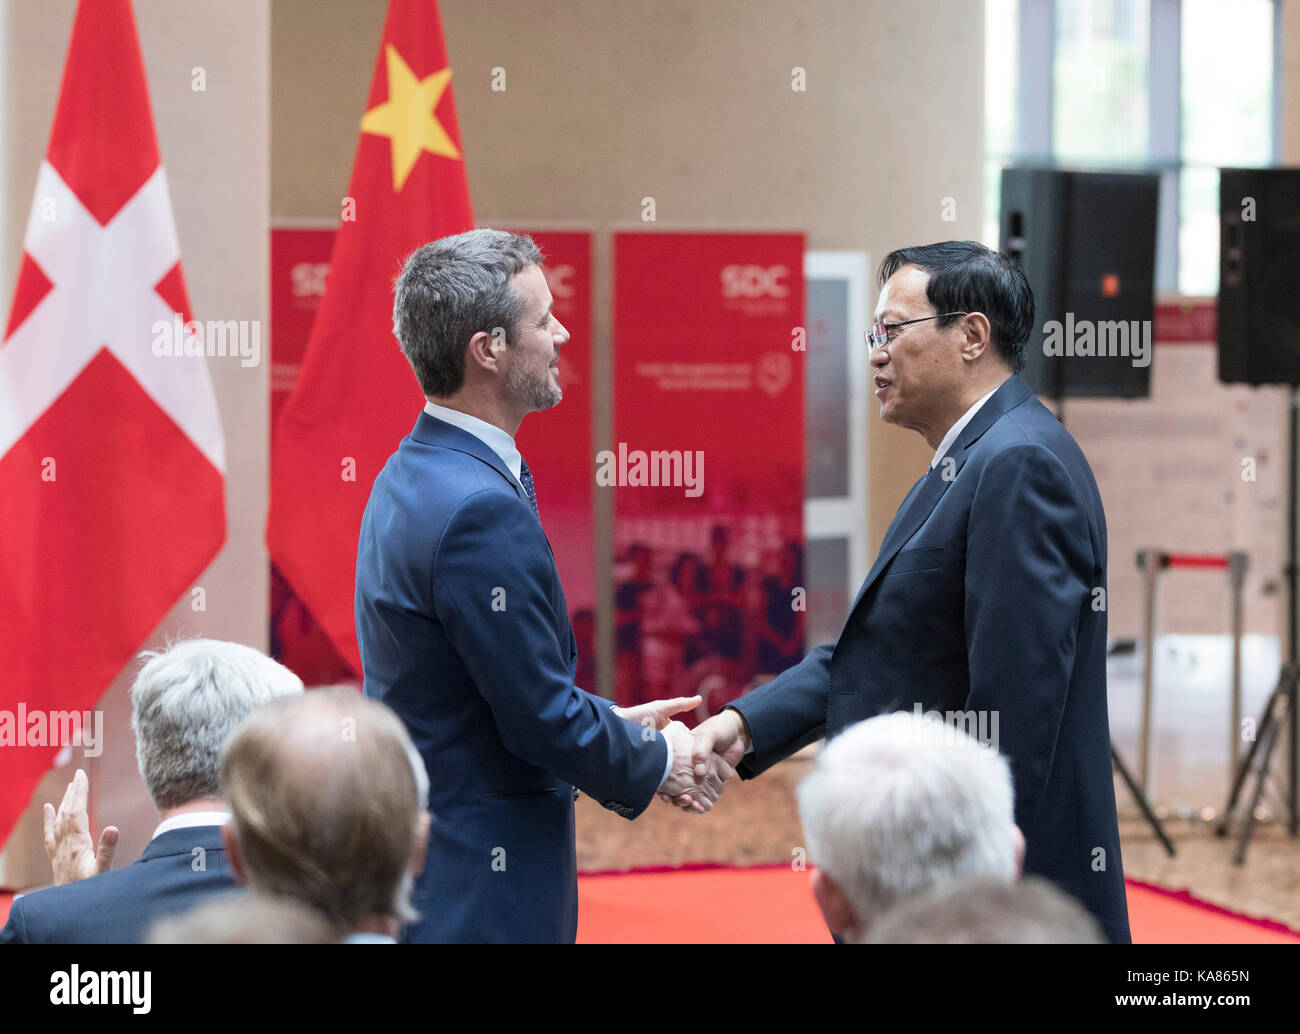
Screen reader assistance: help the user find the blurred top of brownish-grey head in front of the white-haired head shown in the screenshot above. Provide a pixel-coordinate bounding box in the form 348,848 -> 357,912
867,877 -> 1106,944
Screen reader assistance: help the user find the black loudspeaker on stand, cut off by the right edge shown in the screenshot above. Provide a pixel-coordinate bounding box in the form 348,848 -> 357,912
1218,169 -> 1300,385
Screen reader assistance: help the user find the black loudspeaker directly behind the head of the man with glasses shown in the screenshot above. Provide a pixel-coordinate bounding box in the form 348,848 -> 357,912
1000,168 -> 1160,398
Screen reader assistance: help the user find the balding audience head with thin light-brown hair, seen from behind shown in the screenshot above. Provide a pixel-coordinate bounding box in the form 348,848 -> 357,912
222,688 -> 429,936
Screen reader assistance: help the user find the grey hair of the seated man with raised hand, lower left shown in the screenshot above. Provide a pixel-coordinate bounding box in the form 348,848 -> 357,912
131,639 -> 303,809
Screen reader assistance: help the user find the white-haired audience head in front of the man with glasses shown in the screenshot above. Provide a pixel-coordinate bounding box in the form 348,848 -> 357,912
798,711 -> 1024,943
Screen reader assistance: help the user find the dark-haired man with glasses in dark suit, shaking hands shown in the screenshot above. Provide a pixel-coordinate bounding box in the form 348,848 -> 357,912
696,241 -> 1130,942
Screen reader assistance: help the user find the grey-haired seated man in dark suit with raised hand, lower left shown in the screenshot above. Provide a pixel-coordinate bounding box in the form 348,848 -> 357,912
0,639 -> 303,944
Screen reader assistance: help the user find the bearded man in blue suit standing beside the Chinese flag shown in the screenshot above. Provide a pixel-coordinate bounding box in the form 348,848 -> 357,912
356,230 -> 732,943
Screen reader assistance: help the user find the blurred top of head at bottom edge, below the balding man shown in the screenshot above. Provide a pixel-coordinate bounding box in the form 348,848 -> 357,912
147,892 -> 338,944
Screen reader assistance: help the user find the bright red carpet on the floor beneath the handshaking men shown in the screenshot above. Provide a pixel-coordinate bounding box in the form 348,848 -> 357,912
0,865 -> 1300,944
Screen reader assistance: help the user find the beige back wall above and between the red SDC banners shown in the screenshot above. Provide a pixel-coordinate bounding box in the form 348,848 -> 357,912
272,0 -> 984,691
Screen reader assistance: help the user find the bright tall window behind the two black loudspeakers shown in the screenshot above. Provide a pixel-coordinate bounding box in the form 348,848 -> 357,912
984,0 -> 1281,295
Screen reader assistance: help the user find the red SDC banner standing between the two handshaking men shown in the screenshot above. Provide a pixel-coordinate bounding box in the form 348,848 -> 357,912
608,234 -> 806,713
